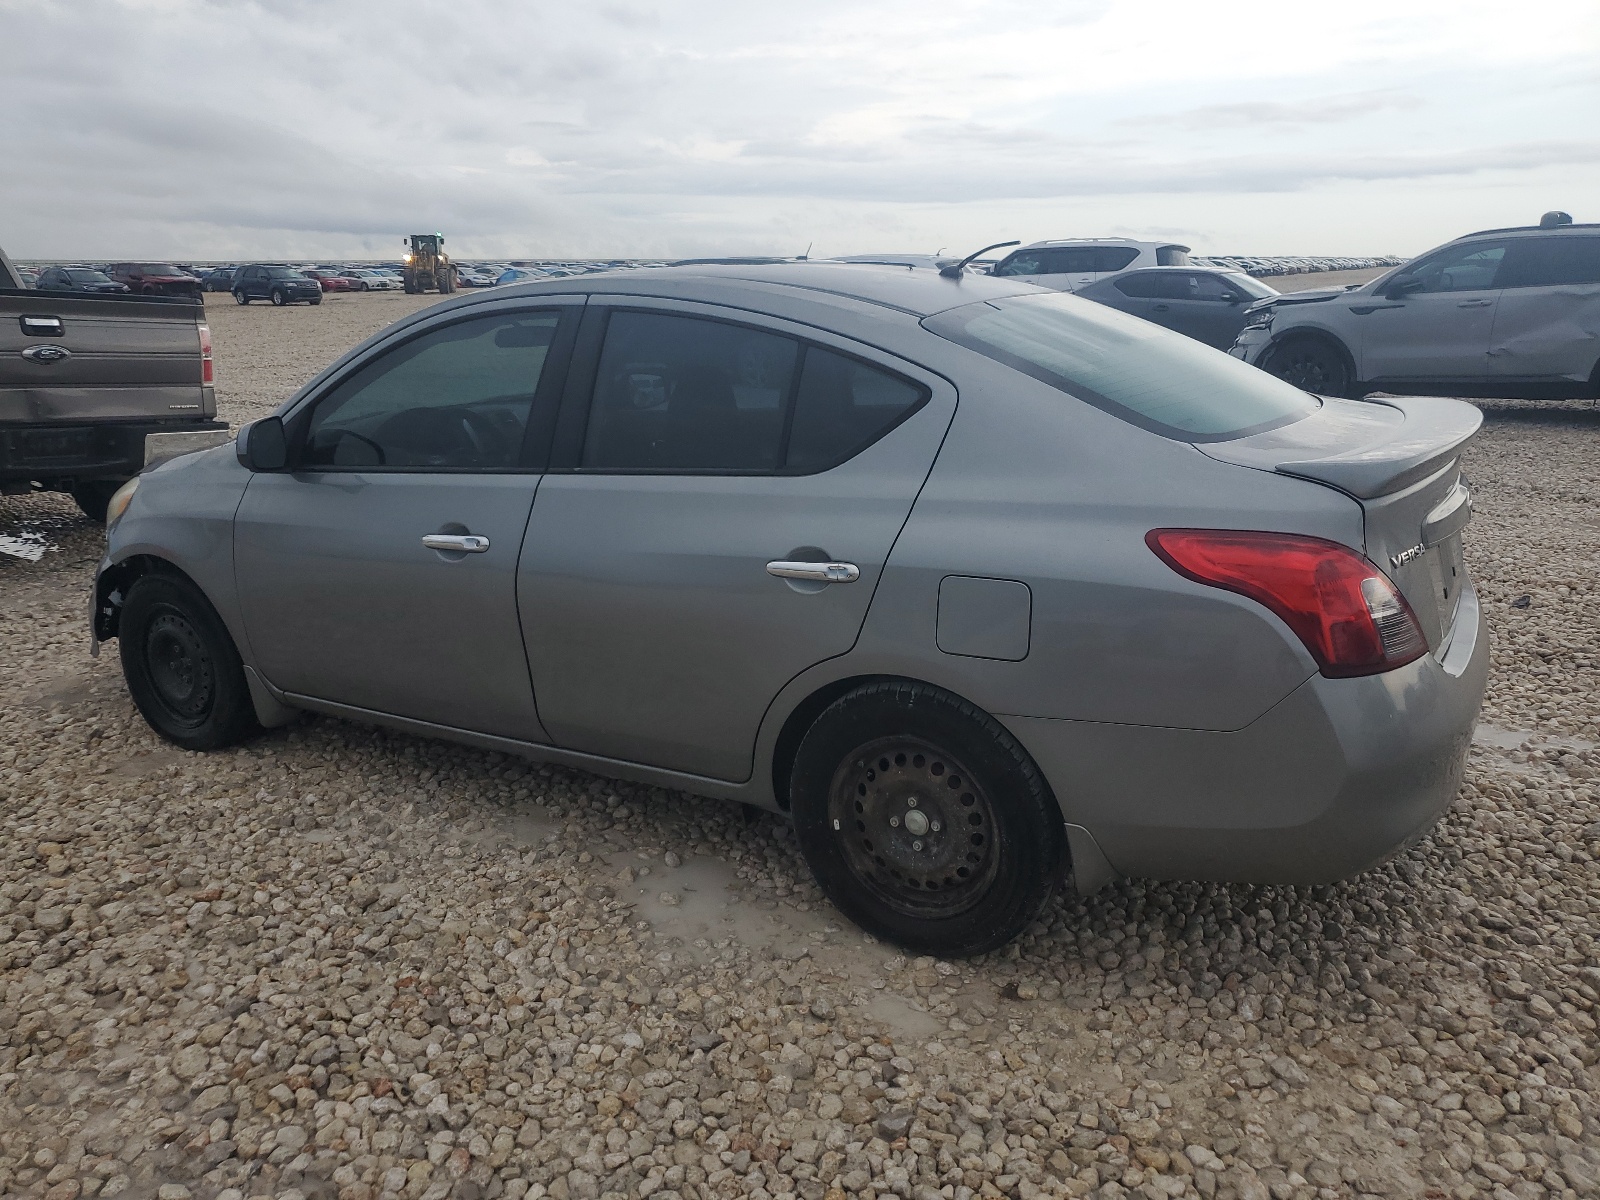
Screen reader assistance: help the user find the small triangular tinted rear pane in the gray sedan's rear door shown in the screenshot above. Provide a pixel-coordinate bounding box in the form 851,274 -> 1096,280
784,346 -> 928,472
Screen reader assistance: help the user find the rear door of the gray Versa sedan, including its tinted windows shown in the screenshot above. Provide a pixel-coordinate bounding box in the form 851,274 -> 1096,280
518,299 -> 955,781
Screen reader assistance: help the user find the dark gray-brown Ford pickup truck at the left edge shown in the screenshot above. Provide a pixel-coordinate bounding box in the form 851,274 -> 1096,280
0,250 -> 227,520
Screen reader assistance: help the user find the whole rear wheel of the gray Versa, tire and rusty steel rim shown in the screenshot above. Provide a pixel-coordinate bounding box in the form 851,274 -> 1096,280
790,683 -> 1067,958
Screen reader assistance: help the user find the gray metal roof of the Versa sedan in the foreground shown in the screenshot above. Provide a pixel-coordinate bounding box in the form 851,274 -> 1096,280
480,259 -> 1046,320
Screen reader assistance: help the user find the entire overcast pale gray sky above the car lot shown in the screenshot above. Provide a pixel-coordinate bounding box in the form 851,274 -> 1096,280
0,0 -> 1600,259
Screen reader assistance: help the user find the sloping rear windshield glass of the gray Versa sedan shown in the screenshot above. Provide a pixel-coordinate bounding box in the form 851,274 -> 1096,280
923,293 -> 1318,442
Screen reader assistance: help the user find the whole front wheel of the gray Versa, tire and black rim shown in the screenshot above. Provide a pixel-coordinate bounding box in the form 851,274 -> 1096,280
117,574 -> 261,750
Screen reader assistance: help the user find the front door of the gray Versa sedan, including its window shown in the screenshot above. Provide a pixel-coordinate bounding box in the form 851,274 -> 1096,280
234,298 -> 581,741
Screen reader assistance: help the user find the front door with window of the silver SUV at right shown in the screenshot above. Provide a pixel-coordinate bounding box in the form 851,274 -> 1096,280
1356,238 -> 1506,382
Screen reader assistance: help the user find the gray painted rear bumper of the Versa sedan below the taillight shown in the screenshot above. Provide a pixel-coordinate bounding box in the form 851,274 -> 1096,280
1003,589 -> 1490,883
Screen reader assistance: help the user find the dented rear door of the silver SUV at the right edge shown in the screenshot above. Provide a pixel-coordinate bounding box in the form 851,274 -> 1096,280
1490,232 -> 1600,382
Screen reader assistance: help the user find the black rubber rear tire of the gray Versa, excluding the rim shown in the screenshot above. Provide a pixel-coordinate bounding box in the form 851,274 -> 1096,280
790,683 -> 1066,958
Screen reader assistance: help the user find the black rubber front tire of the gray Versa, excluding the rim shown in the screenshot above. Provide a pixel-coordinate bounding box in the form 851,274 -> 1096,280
117,574 -> 258,750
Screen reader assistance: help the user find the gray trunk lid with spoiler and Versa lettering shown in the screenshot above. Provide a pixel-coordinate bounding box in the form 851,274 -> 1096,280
1197,397 -> 1483,651
